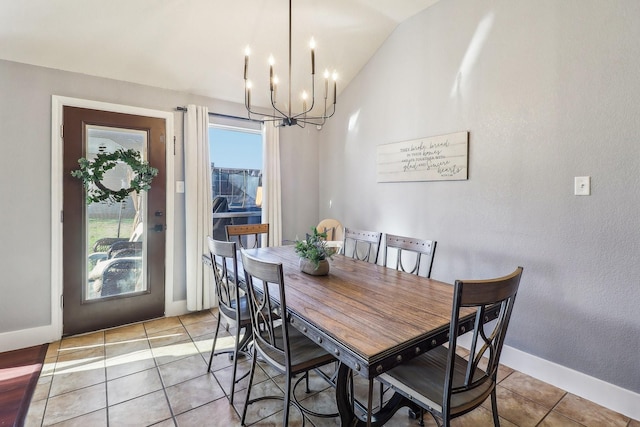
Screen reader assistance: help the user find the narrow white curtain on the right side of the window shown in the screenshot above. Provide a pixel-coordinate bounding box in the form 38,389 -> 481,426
262,122 -> 282,246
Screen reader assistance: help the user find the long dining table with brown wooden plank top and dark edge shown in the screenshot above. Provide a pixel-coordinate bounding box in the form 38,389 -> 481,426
238,246 -> 498,426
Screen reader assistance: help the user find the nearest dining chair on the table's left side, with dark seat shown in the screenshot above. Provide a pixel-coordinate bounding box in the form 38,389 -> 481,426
241,251 -> 338,427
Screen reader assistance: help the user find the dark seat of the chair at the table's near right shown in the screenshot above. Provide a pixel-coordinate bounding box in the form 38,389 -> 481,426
378,346 -> 493,416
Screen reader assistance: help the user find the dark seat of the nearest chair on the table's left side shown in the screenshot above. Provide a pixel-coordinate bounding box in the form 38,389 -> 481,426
258,328 -> 335,375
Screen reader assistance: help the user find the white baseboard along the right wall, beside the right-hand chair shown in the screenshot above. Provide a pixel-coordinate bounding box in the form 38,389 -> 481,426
500,346 -> 640,420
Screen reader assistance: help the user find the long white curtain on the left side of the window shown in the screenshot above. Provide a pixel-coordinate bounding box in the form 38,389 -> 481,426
184,105 -> 217,311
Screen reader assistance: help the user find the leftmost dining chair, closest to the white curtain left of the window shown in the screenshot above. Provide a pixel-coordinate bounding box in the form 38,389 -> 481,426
207,237 -> 252,404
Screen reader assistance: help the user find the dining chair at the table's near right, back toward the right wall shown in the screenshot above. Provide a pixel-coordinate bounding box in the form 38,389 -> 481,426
377,267 -> 522,427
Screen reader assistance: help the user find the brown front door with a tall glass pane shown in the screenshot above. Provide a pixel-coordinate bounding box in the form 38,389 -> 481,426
63,106 -> 166,335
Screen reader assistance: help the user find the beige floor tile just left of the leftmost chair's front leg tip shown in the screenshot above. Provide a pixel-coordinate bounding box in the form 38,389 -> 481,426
167,374 -> 227,414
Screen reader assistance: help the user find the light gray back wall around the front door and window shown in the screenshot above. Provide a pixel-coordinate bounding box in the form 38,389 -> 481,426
0,60 -> 318,342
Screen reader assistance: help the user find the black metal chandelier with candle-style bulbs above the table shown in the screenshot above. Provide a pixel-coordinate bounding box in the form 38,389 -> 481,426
244,0 -> 338,128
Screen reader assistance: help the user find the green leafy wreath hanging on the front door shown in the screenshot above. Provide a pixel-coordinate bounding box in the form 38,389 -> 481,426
71,149 -> 158,204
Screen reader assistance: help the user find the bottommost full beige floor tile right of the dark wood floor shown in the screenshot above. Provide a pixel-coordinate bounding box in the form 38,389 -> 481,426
43,383 -> 107,425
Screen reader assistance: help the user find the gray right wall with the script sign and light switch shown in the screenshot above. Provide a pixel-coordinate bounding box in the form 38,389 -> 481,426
319,0 -> 640,406
